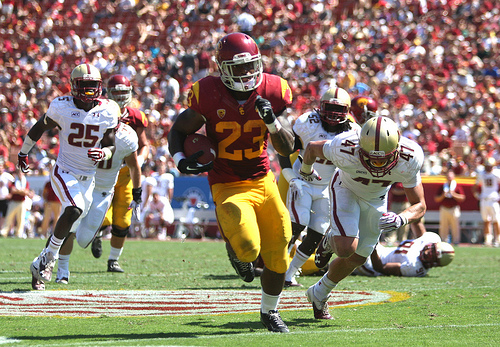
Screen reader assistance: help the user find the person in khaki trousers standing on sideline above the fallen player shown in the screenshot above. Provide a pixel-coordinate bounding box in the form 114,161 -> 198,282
434,169 -> 465,245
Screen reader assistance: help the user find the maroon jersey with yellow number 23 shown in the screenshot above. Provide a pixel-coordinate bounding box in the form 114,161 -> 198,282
188,73 -> 292,185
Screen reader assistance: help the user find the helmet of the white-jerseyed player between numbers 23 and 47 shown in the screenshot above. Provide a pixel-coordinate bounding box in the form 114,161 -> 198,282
318,87 -> 351,126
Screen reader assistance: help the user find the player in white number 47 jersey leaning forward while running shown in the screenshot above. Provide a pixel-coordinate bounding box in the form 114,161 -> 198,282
301,117 -> 426,319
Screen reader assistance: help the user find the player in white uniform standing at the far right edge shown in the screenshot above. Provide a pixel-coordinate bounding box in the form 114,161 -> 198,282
472,157 -> 500,247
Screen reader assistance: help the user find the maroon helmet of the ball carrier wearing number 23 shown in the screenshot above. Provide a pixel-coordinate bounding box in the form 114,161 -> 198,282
215,33 -> 263,92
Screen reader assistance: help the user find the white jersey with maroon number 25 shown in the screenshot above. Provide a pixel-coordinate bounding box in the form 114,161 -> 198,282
46,95 -> 120,176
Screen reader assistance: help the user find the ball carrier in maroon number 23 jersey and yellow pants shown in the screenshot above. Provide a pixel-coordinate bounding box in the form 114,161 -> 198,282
169,33 -> 294,332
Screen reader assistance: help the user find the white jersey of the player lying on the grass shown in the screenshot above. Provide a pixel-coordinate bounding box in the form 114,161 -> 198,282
355,232 -> 441,277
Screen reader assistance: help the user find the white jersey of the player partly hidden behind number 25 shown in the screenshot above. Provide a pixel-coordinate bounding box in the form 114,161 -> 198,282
94,122 -> 139,191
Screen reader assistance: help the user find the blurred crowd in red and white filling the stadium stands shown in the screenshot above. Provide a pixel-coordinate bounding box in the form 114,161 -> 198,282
0,0 -> 500,176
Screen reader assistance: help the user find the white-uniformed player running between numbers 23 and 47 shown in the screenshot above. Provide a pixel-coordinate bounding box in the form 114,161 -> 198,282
279,87 -> 359,287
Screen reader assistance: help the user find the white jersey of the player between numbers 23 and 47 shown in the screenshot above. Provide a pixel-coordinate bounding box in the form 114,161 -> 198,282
293,111 -> 360,185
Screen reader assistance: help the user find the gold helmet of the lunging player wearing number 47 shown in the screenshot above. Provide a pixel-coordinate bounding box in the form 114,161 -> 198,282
359,117 -> 401,177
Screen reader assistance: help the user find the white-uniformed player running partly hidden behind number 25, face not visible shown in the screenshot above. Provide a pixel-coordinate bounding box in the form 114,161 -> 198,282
52,122 -> 142,284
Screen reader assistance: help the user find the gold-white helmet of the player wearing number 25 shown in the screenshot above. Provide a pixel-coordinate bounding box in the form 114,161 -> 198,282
70,64 -> 102,103
